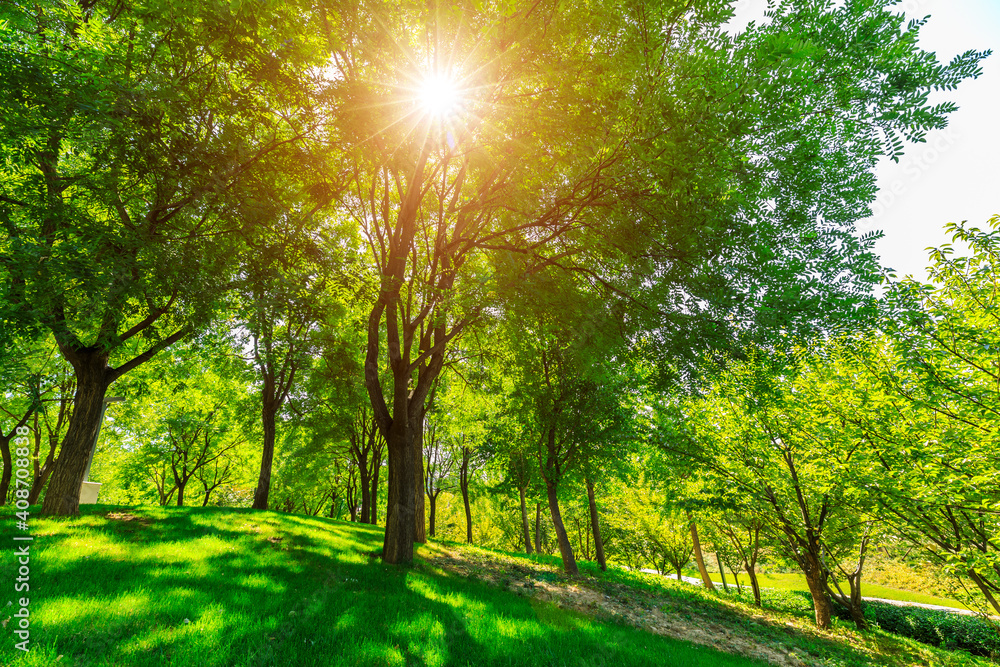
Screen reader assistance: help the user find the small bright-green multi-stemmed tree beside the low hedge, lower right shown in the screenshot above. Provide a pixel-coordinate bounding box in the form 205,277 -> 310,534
680,355 -> 875,628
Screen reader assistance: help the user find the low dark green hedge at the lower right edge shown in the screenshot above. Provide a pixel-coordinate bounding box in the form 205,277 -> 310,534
842,602 -> 1000,657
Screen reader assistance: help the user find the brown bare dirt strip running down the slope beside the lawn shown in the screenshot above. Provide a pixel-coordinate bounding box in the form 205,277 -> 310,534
426,549 -> 844,667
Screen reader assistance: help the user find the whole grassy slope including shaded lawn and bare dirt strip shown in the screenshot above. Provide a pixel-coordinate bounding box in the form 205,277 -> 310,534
0,505 -> 990,667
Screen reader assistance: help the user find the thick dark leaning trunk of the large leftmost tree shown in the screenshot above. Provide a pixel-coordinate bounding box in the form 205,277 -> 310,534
42,346 -> 112,516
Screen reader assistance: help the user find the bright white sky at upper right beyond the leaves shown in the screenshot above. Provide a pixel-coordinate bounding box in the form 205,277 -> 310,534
735,0 -> 1000,280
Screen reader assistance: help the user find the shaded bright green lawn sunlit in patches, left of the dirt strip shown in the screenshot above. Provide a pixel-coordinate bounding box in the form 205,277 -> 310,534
0,505 -> 764,667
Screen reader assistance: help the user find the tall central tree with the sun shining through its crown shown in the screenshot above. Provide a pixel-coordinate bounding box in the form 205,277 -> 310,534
336,2 -> 752,562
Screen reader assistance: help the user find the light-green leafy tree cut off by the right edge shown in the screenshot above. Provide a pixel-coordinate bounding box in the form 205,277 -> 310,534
836,217 -> 1000,613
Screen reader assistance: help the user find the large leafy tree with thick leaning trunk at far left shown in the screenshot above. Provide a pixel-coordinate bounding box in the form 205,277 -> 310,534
0,0 -> 328,515
